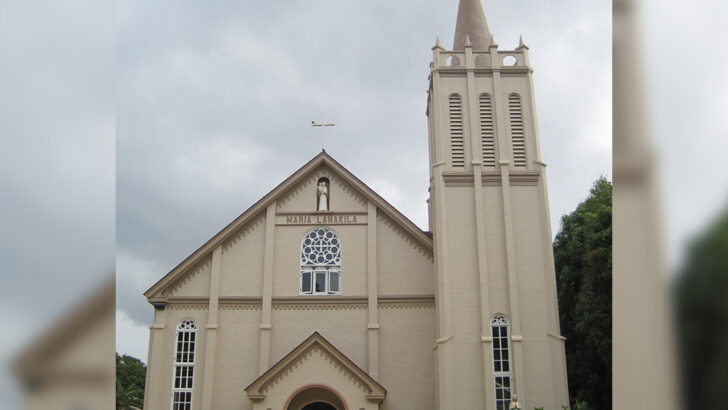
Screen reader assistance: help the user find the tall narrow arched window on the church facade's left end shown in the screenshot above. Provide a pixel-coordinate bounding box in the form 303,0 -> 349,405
172,319 -> 197,410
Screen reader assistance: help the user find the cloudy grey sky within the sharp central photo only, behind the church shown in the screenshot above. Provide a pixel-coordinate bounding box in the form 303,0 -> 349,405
116,0 -> 611,360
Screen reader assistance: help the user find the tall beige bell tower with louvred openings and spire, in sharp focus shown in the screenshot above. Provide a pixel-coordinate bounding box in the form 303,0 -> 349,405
427,0 -> 569,410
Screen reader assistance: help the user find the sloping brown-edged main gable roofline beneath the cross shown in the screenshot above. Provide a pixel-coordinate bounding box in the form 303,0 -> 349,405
144,150 -> 432,302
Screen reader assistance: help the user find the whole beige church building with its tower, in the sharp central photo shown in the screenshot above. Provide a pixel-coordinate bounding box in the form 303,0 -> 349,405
144,0 -> 569,410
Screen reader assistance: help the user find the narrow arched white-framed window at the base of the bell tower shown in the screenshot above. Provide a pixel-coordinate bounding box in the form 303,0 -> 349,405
490,314 -> 513,410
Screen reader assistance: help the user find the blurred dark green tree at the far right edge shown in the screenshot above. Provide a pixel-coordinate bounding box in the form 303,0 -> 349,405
675,208 -> 728,410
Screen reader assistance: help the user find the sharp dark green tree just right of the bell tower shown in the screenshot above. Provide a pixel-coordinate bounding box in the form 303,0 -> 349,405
554,177 -> 612,410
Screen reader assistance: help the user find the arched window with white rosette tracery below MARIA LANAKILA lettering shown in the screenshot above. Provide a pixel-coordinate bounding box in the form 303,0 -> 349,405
299,228 -> 341,295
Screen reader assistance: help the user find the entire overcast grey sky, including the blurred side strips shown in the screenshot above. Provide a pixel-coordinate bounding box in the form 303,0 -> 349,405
0,0 -> 728,409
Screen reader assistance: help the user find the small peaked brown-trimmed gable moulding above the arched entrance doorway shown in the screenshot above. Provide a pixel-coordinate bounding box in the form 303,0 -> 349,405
244,332 -> 387,402
